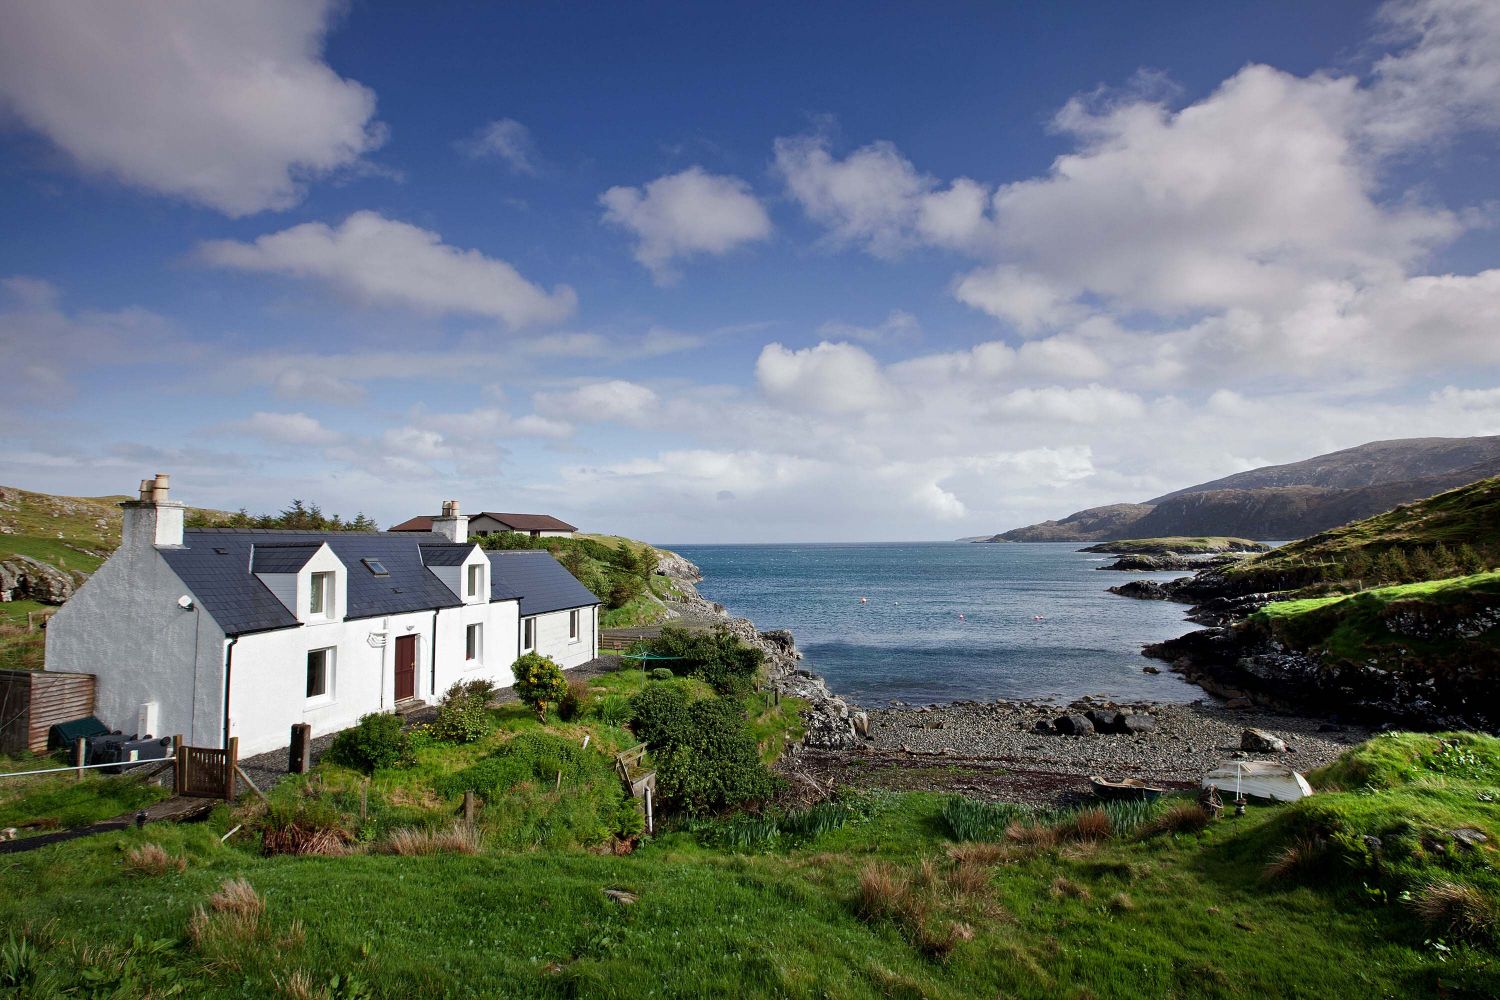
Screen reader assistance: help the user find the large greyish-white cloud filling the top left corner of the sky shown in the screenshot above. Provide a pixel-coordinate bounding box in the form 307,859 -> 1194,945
0,0 -> 384,216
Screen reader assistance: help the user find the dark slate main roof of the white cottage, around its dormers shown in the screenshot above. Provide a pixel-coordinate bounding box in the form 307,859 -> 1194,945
158,528 -> 525,636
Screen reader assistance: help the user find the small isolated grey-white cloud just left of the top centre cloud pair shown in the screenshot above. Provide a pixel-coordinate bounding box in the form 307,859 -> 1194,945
599,166 -> 771,285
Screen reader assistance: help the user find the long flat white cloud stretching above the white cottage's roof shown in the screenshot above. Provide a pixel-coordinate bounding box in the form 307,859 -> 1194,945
198,211 -> 578,328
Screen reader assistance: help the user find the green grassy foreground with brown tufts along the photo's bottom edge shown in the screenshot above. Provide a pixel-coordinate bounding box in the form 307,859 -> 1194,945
0,735 -> 1500,1000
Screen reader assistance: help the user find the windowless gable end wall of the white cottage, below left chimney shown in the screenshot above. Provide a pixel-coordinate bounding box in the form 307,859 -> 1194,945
47,546 -> 224,747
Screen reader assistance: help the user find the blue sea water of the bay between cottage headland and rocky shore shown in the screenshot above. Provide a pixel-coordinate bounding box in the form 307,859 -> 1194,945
671,543 -> 1203,708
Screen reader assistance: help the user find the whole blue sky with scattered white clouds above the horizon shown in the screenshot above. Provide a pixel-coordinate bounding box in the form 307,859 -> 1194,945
0,0 -> 1500,543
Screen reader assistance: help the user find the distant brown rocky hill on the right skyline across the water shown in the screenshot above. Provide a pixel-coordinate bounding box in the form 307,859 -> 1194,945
990,436 -> 1500,541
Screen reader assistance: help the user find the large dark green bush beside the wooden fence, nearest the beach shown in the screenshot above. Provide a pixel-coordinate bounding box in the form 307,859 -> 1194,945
642,688 -> 780,816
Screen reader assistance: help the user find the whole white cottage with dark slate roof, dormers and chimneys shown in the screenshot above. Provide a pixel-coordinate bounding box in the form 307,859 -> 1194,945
47,475 -> 600,754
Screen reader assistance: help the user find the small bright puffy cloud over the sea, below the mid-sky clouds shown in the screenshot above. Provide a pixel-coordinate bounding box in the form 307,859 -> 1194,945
755,340 -> 893,414
